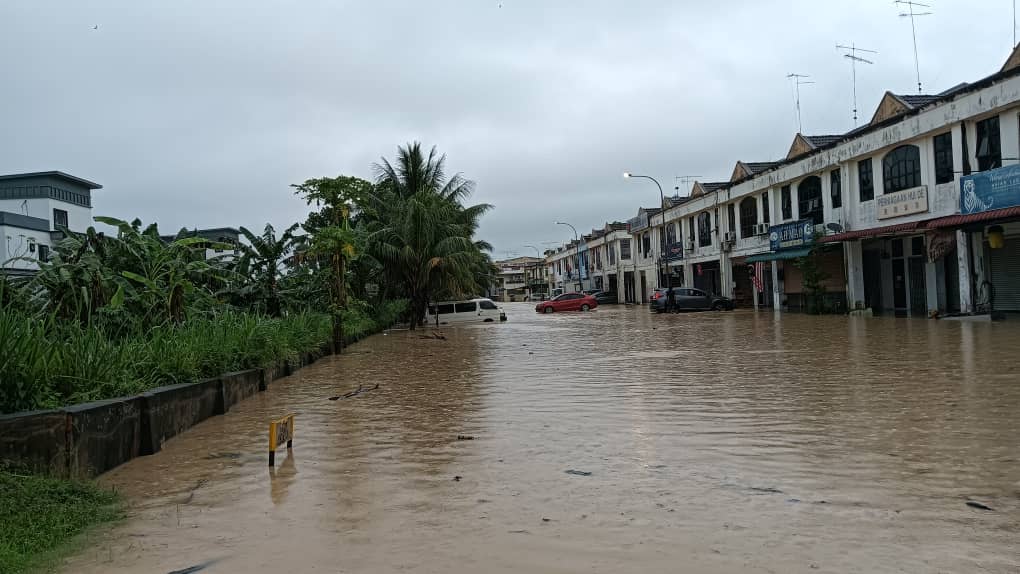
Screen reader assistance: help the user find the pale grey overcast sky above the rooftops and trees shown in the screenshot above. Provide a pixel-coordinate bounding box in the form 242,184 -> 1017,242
0,0 -> 1013,258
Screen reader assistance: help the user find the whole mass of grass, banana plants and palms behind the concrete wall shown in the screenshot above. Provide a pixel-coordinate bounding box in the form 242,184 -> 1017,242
0,144 -> 492,413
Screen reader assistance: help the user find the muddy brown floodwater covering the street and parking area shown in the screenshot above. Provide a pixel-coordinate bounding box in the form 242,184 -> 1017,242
64,304 -> 1020,574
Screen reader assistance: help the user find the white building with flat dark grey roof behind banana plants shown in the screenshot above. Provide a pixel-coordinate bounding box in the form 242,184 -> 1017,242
0,171 -> 102,273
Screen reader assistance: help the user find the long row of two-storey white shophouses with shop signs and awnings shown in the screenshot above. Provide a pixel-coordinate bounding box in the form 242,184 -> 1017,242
547,47 -> 1020,316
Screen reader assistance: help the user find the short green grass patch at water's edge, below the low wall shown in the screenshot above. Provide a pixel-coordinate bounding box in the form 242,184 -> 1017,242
0,468 -> 120,574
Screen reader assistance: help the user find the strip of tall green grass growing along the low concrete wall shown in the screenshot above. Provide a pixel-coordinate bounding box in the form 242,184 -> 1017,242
0,301 -> 406,413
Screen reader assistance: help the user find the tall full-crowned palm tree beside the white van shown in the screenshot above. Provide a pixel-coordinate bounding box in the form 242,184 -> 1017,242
368,142 -> 492,329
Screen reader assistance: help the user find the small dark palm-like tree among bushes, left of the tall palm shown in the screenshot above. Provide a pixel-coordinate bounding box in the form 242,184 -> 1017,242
235,223 -> 305,317
